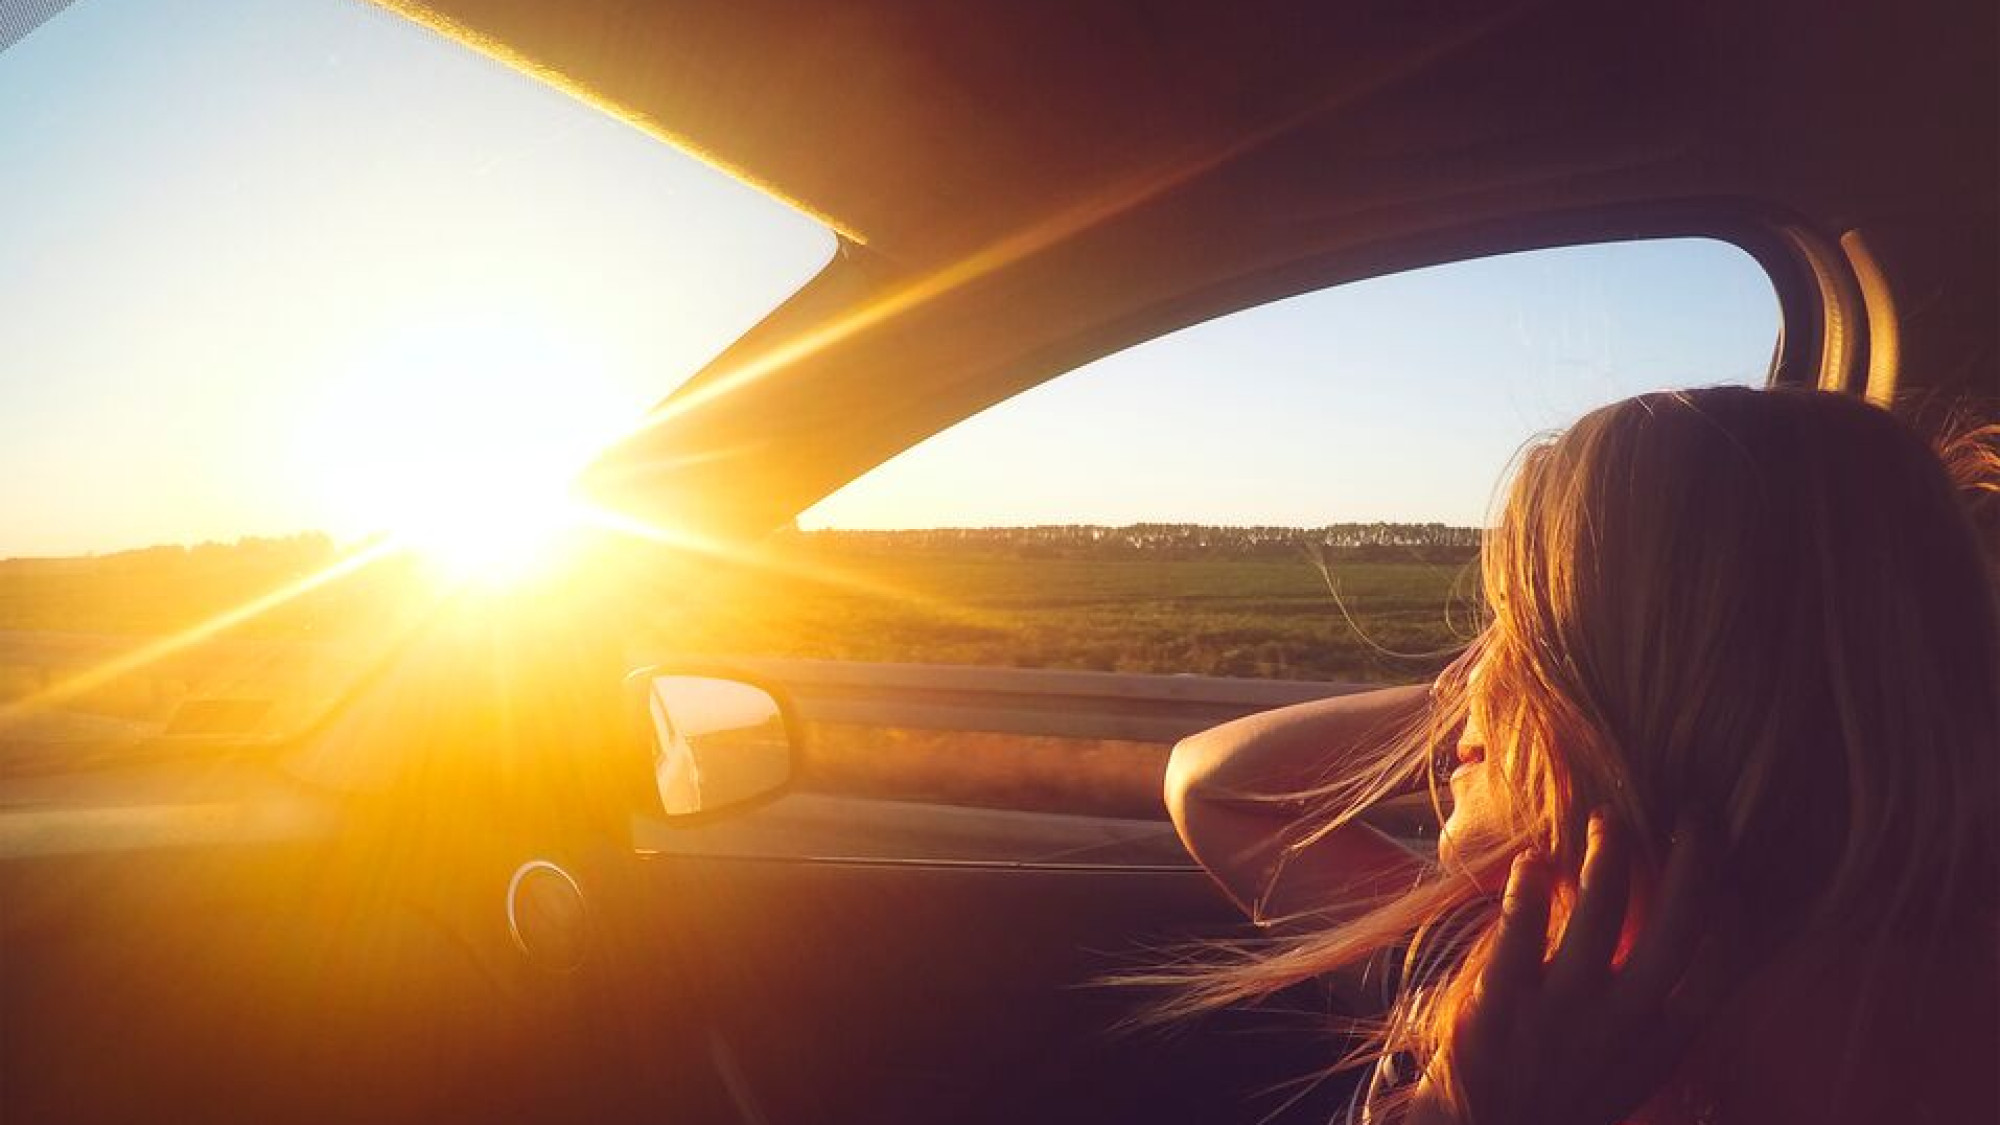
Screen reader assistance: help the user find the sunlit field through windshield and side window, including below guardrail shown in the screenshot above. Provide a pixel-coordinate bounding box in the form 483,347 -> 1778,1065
0,528 -> 1476,804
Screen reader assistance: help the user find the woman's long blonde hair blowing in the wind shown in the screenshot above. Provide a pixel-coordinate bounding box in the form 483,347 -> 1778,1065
1160,388 -> 2000,1109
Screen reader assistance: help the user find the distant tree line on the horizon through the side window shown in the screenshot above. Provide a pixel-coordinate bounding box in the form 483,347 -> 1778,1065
786,522 -> 1480,560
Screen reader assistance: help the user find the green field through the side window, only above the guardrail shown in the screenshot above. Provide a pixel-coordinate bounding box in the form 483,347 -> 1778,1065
654,536 -> 1476,681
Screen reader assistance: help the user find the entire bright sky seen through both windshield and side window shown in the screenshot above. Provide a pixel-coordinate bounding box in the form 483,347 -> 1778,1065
0,0 -> 1778,554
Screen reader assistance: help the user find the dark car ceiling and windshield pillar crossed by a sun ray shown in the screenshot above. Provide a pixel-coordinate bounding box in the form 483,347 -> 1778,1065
372,0 -> 2000,530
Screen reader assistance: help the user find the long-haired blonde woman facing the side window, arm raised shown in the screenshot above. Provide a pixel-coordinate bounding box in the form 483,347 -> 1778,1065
1168,388 -> 2000,1125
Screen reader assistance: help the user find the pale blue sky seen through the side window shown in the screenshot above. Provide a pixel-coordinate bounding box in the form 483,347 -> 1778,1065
800,240 -> 1778,526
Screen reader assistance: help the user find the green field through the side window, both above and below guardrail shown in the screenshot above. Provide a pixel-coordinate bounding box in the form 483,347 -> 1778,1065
656,536 -> 1476,817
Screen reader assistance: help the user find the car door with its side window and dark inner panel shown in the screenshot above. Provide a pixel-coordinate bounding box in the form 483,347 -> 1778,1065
604,240 -> 1776,1121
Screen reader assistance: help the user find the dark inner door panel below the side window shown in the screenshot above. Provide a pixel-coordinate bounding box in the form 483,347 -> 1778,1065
642,840 -> 1360,1125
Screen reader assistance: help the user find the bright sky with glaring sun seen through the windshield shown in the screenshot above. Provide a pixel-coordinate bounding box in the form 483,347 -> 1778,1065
0,0 -> 834,554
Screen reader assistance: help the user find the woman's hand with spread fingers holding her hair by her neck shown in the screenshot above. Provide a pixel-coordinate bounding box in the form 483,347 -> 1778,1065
1408,817 -> 1716,1125
